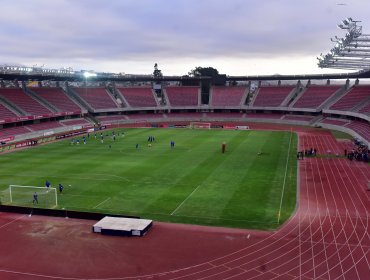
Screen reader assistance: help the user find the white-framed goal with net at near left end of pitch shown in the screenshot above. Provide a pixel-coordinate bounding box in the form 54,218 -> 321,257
3,185 -> 58,208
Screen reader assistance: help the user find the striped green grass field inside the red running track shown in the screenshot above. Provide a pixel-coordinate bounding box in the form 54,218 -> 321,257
0,129 -> 297,229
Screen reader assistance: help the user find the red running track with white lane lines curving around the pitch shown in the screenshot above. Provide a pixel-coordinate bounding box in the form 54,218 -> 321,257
0,129 -> 370,280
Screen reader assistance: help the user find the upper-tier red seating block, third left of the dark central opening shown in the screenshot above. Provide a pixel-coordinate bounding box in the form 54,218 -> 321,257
72,87 -> 118,110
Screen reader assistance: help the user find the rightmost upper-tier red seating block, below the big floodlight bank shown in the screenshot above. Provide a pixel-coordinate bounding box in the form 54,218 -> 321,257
329,86 -> 370,111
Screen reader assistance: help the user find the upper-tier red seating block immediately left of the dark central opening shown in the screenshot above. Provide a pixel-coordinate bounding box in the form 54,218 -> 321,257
164,87 -> 200,107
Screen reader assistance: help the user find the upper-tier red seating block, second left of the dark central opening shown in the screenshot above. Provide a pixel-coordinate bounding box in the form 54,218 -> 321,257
117,87 -> 157,108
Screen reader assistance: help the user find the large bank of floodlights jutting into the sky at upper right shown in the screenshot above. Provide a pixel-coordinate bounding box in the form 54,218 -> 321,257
317,17 -> 370,70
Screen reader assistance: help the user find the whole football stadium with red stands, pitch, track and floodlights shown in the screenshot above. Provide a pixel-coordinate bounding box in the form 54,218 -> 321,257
0,2 -> 370,280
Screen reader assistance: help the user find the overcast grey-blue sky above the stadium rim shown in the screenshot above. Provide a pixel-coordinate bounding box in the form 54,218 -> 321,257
0,0 -> 370,75
